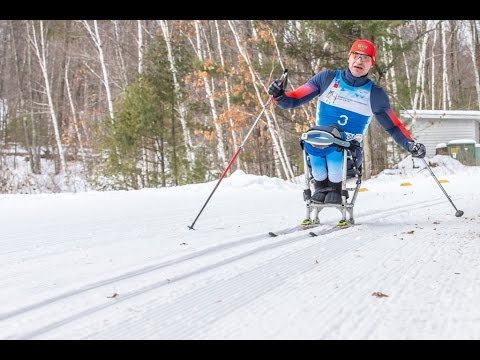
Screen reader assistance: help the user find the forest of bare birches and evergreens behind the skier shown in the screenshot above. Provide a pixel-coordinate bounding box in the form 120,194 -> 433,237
0,20 -> 480,193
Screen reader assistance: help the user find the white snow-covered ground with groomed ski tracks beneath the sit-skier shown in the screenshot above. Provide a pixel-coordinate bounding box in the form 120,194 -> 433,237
0,156 -> 480,339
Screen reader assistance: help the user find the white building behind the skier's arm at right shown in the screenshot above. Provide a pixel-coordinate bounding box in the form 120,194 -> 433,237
400,110 -> 480,157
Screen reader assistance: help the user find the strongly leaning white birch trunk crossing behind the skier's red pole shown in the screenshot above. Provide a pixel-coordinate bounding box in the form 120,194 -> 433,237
227,20 -> 293,180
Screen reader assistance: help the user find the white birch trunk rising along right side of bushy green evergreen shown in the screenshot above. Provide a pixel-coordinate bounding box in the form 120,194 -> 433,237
158,20 -> 195,163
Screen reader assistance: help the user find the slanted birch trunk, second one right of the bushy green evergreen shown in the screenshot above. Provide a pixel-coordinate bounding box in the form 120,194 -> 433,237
194,20 -> 227,166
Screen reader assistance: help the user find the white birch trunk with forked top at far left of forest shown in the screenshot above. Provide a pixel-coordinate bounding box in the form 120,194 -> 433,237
29,20 -> 67,173
